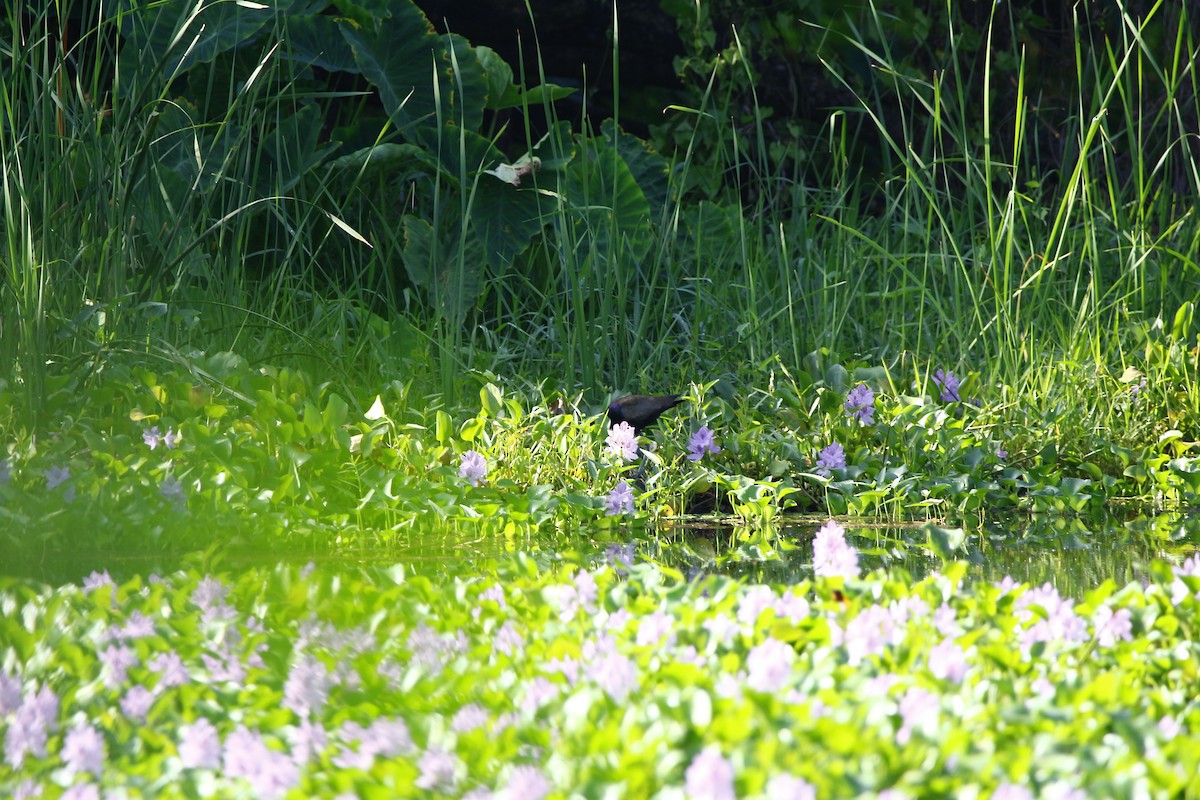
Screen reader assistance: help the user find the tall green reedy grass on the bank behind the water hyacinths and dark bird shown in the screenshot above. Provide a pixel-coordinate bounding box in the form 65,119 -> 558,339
0,0 -> 1200,434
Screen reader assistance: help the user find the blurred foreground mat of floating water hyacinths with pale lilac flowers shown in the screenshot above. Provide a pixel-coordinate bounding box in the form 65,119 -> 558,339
0,523 -> 1200,800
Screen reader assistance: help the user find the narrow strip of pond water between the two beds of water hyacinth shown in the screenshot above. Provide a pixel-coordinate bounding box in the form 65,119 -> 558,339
0,513 -> 1200,587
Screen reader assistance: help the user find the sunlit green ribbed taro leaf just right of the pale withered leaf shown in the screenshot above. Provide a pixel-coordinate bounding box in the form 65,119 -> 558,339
564,131 -> 652,261
